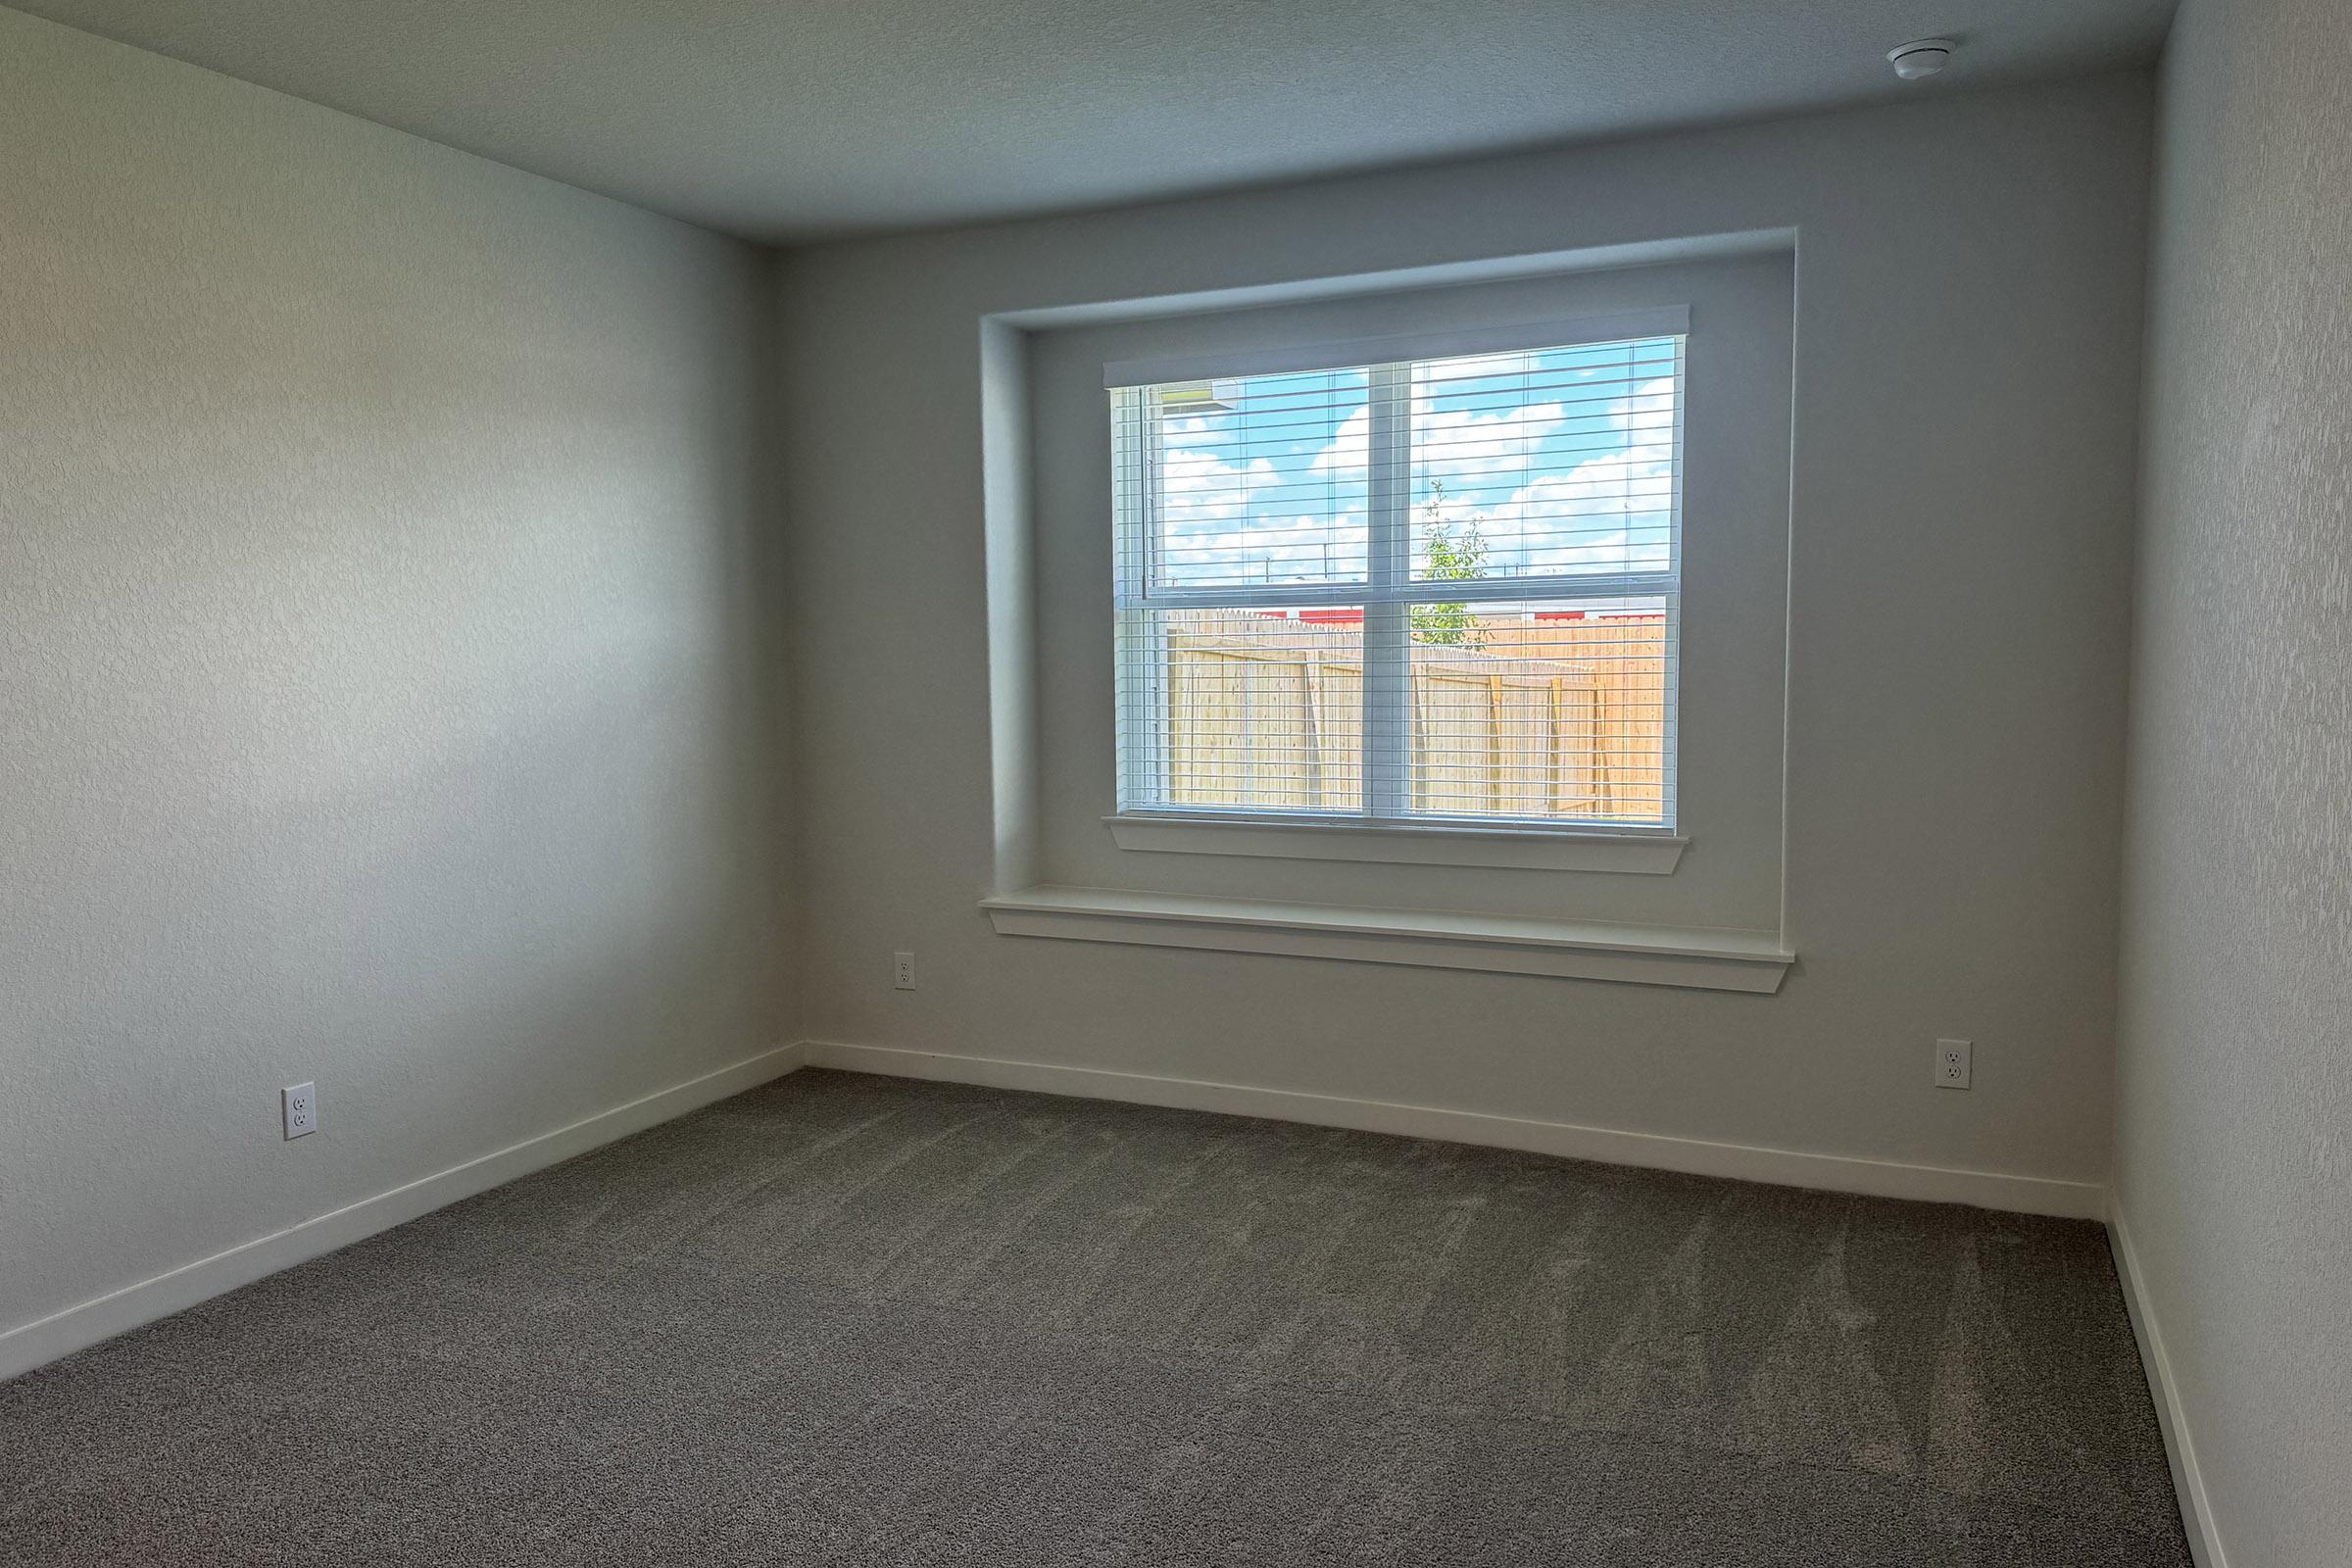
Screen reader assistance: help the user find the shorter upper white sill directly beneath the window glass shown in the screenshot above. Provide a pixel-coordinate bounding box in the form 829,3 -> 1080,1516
1103,811 -> 1691,877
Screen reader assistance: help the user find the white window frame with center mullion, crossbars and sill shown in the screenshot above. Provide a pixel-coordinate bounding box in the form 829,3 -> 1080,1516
1103,306 -> 1691,872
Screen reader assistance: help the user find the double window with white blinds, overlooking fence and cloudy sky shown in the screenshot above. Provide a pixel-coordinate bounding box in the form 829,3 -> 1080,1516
1105,315 -> 1687,832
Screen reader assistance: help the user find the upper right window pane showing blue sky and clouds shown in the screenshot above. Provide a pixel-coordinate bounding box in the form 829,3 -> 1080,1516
1413,338 -> 1682,578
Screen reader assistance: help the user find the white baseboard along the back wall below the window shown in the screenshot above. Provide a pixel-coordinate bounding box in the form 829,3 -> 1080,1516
807,1039 -> 2107,1220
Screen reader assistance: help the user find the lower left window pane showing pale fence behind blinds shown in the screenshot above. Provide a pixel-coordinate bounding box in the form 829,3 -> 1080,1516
1119,609 -> 1364,811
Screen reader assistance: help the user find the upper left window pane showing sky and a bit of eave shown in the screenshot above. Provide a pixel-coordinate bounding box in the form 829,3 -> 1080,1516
1146,369 -> 1369,590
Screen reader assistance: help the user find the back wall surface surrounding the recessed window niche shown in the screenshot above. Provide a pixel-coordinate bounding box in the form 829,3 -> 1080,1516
781,75 -> 2150,1183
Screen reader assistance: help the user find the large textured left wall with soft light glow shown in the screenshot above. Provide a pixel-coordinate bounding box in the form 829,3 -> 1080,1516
0,12 -> 793,1331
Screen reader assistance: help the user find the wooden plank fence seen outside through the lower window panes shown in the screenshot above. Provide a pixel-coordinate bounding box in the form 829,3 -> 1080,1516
1166,612 -> 1665,823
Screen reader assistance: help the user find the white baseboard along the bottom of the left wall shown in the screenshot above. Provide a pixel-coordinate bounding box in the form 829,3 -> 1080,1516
0,1044 -> 805,1380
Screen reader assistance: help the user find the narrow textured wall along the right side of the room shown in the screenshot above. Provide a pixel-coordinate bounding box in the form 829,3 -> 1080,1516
2117,0 -> 2352,1568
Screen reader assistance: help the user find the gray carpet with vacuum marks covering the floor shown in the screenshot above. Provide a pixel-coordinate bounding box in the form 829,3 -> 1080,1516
0,1072 -> 2189,1568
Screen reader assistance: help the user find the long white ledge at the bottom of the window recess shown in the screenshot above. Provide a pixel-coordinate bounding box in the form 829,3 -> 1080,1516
981,886 -> 1797,995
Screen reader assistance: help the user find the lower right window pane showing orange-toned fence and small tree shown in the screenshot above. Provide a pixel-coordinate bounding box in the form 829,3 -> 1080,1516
1411,600 -> 1675,825
